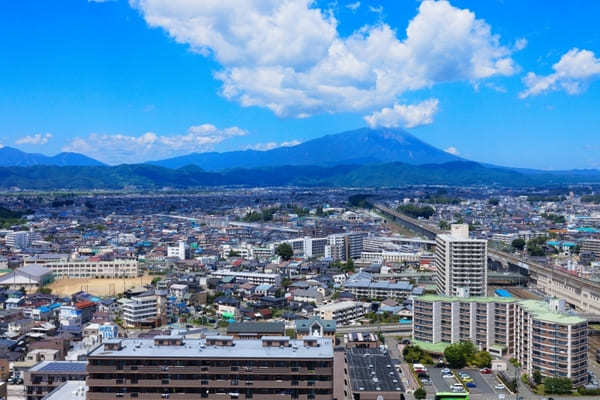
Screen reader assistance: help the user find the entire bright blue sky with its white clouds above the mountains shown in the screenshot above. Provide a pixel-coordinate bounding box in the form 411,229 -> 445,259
0,0 -> 600,169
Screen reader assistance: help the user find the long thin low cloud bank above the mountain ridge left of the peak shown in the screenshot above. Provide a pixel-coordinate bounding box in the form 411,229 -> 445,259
63,124 -> 247,164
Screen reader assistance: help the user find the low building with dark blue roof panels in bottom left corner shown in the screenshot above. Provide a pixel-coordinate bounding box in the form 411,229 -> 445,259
23,361 -> 87,400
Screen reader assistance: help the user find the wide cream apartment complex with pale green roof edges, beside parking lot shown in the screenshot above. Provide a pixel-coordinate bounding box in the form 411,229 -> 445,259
413,295 -> 588,386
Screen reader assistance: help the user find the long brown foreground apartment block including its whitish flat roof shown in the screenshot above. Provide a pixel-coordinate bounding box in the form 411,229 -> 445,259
87,336 -> 333,400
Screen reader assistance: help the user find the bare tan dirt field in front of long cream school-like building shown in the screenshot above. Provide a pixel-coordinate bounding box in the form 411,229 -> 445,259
47,275 -> 154,296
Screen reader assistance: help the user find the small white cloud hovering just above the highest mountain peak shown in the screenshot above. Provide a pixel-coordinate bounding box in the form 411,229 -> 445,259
364,99 -> 439,128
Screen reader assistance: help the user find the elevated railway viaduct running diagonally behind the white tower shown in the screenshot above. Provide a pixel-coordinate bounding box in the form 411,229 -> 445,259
373,204 -> 600,314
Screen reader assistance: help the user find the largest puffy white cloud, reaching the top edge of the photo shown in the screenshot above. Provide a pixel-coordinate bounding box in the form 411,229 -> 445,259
130,0 -> 517,117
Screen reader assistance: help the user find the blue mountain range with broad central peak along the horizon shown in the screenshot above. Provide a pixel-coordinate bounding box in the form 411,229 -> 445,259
0,128 -> 600,189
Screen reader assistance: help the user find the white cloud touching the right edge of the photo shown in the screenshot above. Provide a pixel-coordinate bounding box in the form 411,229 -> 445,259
519,48 -> 600,99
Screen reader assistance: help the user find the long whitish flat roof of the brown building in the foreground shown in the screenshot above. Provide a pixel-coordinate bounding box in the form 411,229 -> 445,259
89,338 -> 333,359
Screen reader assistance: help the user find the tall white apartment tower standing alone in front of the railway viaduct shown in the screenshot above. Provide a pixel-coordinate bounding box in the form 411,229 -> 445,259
435,224 -> 487,296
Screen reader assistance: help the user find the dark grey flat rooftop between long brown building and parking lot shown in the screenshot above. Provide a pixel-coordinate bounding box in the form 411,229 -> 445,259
346,348 -> 404,392
